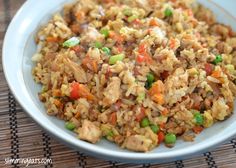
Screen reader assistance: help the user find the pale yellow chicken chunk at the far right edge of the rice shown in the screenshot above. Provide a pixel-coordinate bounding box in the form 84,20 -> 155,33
212,98 -> 229,121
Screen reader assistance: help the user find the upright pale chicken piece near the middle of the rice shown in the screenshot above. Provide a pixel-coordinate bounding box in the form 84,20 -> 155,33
103,77 -> 121,106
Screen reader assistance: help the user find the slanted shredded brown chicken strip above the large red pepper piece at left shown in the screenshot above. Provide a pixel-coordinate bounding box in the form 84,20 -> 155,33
64,58 -> 88,83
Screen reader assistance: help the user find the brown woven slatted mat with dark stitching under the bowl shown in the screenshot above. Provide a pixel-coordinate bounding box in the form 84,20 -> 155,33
0,0 -> 236,168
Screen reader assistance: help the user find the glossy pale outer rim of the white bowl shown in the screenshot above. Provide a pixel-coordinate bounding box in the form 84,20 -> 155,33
2,0 -> 236,162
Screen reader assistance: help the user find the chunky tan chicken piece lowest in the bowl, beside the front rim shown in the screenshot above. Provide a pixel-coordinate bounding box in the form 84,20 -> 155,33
123,135 -> 152,152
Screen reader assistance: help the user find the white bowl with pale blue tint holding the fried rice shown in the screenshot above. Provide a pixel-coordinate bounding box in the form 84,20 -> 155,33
3,0 -> 236,163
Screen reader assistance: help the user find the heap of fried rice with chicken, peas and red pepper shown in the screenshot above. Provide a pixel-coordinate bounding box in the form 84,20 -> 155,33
32,0 -> 236,152
